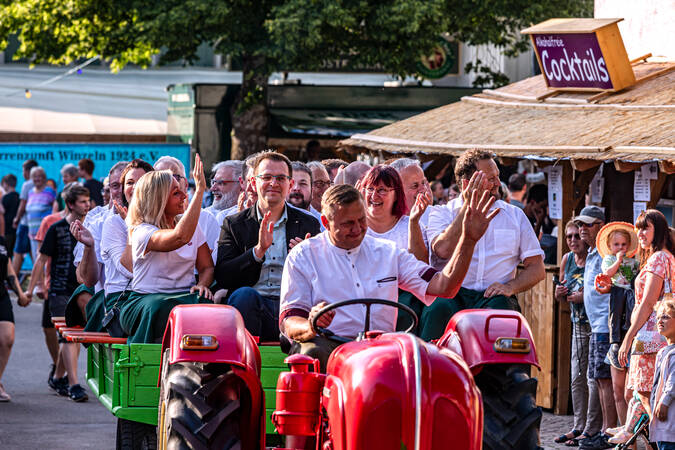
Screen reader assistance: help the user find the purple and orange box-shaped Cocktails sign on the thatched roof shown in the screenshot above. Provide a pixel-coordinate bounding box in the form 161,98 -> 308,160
523,19 -> 635,91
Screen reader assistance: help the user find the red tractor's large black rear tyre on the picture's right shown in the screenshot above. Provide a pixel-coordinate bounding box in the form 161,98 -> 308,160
475,364 -> 542,450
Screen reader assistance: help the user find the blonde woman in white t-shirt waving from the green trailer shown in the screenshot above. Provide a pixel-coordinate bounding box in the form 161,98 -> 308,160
120,156 -> 213,343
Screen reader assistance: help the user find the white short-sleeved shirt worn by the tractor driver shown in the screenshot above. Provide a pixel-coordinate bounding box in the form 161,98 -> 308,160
279,232 -> 436,338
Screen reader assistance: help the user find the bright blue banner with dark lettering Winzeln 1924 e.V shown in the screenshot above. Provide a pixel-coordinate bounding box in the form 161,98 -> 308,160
0,143 -> 190,191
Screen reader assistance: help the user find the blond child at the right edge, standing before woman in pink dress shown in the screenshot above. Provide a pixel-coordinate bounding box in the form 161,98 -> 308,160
649,297 -> 675,450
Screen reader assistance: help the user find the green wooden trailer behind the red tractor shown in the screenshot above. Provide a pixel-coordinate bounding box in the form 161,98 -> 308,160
87,343 -> 288,448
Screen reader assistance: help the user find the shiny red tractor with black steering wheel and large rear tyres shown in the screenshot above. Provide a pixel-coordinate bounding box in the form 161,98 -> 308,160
158,299 -> 541,450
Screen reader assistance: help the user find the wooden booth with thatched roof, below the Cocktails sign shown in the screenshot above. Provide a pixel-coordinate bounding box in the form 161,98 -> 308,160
340,29 -> 675,414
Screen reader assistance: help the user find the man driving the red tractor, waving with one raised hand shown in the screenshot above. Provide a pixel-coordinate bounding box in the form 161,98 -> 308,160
279,172 -> 499,371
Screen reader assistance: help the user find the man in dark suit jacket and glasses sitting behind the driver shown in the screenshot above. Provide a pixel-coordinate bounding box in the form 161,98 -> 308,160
215,152 -> 320,341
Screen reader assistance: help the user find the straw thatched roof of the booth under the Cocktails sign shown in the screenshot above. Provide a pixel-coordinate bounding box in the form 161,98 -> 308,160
340,63 -> 675,163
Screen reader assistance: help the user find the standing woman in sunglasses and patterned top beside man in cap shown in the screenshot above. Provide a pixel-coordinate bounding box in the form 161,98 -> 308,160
555,221 -> 591,446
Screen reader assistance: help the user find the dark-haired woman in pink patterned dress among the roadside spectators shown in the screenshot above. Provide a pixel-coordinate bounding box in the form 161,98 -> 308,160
619,209 -> 675,415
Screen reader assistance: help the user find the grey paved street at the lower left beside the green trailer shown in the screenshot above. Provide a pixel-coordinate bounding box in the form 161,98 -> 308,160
0,302 -> 116,450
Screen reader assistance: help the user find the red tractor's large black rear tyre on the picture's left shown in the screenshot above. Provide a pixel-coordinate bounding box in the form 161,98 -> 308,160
157,350 -> 247,450
